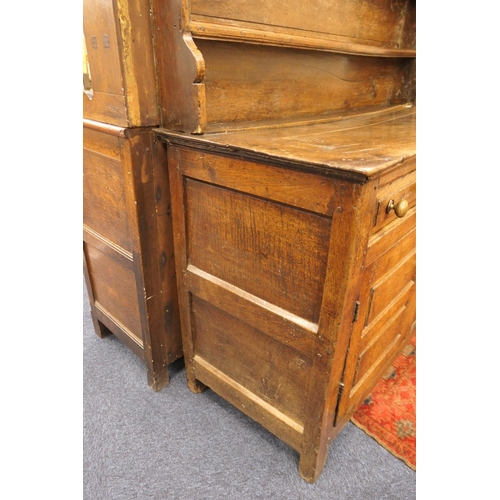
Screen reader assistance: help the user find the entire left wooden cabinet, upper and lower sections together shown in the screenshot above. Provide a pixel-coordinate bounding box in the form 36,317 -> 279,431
83,0 -> 186,390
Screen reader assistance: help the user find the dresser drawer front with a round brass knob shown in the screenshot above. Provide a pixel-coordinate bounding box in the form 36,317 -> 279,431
372,170 -> 417,233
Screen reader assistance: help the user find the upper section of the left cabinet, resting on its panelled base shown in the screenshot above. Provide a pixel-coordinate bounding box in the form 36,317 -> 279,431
83,0 -> 160,127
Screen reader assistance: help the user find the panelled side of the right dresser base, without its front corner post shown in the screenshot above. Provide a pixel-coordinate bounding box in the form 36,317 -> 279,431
169,148 -> 334,450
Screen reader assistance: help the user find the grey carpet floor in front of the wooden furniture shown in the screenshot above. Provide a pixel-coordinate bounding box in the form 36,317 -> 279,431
83,285 -> 416,500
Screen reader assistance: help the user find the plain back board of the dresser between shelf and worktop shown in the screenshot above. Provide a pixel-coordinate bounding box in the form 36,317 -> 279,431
197,40 -> 410,127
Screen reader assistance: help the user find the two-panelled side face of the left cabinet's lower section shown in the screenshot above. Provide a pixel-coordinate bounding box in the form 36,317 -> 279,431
83,122 -> 143,357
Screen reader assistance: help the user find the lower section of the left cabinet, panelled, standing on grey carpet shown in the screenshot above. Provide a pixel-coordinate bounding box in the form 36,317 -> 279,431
83,120 -> 182,390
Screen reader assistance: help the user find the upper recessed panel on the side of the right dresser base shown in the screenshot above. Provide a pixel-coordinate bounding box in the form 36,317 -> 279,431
185,179 -> 330,323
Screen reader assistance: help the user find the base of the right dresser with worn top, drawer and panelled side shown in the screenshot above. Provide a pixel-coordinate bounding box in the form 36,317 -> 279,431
157,105 -> 416,482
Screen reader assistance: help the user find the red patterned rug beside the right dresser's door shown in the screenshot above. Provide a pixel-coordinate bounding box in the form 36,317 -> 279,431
351,338 -> 417,470
